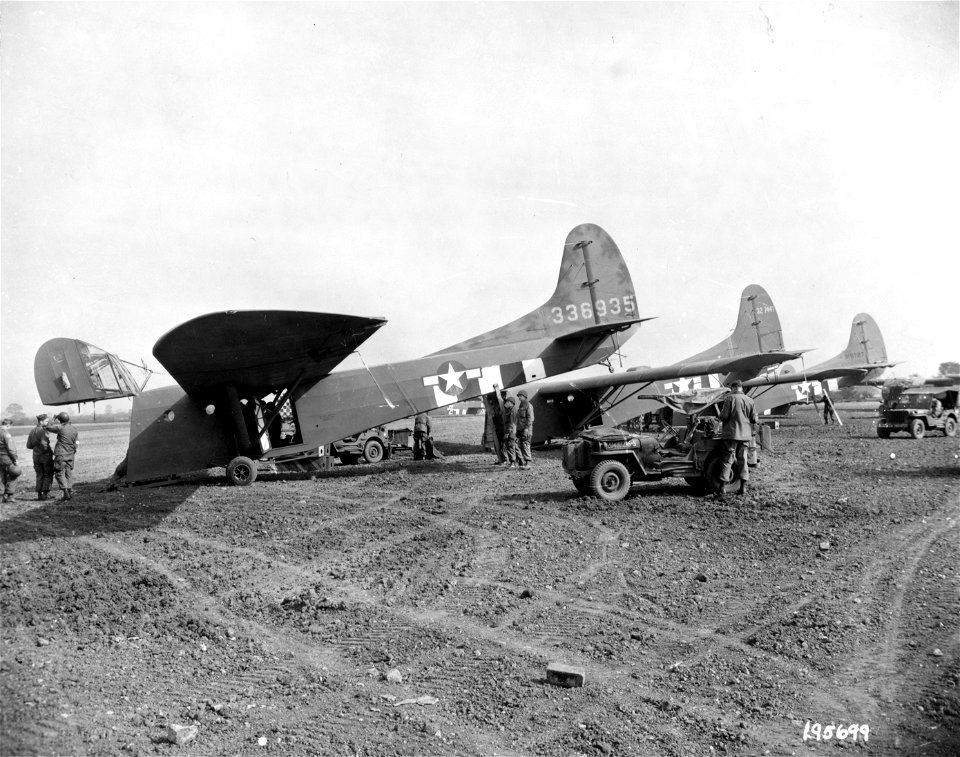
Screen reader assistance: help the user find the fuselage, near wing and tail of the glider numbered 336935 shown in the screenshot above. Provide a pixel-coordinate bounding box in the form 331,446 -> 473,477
38,224 -> 647,485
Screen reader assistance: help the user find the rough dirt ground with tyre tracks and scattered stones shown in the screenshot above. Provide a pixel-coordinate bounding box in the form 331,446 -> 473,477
0,405 -> 960,756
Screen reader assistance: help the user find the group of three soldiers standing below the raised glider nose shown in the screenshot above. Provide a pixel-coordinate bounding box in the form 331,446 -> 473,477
0,413 -> 79,502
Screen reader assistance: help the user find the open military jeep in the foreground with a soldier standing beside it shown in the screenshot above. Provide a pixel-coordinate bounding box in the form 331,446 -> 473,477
563,417 -> 766,501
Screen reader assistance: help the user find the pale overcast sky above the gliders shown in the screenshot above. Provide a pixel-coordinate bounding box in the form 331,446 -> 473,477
0,2 -> 960,410
